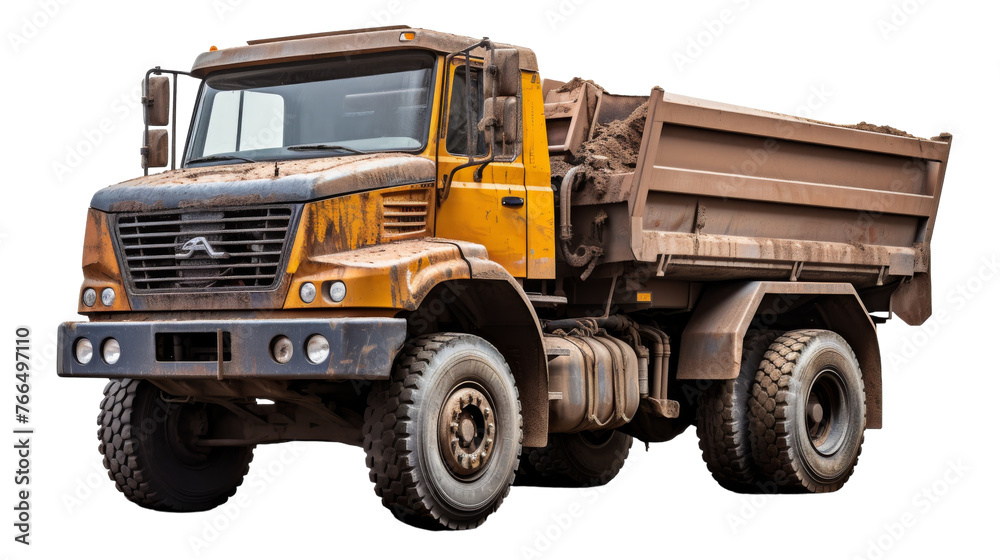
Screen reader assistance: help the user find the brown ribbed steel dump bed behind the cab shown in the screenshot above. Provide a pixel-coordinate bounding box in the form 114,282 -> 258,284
546,82 -> 951,322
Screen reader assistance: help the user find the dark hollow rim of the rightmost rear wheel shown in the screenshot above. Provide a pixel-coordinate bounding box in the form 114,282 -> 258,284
802,368 -> 850,457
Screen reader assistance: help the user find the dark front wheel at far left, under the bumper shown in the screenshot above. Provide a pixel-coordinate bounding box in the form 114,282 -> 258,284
97,379 -> 253,511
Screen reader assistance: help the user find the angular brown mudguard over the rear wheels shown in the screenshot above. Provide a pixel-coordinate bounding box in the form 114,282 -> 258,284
677,282 -> 882,428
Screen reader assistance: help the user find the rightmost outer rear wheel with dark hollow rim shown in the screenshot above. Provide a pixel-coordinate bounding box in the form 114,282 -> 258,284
750,330 -> 865,492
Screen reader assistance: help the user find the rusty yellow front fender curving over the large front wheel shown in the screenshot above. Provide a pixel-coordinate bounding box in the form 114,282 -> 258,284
285,238 -> 549,447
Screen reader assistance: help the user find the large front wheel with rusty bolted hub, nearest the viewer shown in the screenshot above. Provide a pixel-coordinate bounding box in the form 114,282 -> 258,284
364,333 -> 522,529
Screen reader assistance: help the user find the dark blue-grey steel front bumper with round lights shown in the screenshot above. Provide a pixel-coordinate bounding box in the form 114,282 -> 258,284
57,318 -> 406,380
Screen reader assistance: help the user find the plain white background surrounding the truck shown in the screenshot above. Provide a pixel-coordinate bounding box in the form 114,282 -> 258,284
0,0 -> 1000,558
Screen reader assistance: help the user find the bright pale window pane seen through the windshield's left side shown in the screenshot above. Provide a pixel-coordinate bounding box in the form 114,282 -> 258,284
203,91 -> 285,156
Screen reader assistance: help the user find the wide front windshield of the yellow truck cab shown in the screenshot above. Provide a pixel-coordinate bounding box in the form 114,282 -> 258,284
185,51 -> 434,166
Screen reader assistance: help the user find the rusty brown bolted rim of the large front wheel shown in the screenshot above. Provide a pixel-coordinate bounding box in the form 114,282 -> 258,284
438,383 -> 497,481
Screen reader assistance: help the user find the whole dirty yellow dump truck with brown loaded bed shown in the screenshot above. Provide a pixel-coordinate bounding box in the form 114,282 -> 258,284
58,27 -> 951,529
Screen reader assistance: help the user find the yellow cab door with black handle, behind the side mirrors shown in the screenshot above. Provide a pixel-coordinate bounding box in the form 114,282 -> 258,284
435,57 -> 527,278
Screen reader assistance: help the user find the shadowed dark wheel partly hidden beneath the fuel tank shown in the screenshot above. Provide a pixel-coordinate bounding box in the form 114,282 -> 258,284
519,430 -> 632,488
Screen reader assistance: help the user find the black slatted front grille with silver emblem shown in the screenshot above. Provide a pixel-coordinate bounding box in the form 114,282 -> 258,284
117,206 -> 295,292
